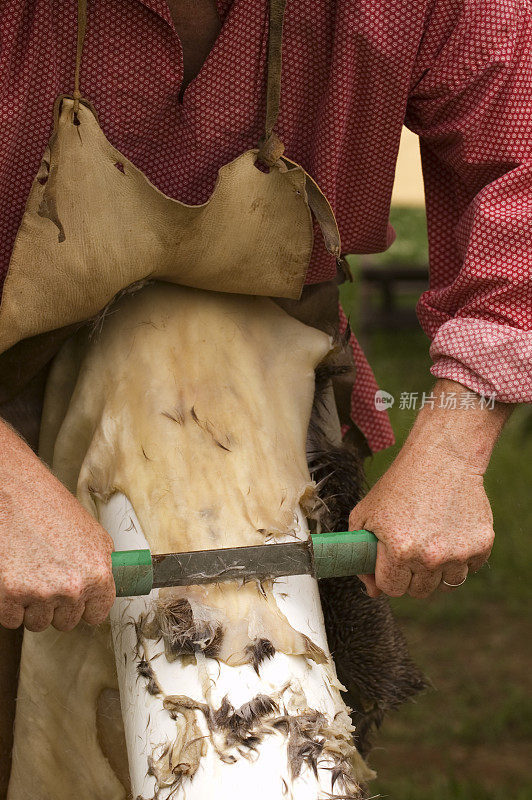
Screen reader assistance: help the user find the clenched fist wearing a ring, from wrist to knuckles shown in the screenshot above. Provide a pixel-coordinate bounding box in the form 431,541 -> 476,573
350,452 -> 495,598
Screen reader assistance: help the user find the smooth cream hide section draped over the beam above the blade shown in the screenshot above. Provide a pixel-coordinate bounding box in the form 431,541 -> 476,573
43,284 -> 331,552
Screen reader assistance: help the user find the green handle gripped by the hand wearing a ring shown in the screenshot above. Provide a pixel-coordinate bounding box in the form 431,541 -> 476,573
311,530 -> 378,578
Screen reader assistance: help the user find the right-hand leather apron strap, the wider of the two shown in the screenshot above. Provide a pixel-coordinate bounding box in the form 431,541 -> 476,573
258,0 -> 286,167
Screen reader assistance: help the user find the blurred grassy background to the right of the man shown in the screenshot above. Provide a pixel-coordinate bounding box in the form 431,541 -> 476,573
342,131 -> 532,800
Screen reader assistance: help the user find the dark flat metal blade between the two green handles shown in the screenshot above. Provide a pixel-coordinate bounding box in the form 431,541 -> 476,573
152,539 -> 314,589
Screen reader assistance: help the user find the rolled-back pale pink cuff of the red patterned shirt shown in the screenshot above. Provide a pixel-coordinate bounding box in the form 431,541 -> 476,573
430,317 -> 532,403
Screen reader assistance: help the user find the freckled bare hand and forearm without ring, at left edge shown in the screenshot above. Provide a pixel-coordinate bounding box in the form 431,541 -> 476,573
0,420 -> 115,631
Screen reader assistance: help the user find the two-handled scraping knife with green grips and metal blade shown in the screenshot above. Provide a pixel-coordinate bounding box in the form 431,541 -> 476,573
112,530 -> 377,597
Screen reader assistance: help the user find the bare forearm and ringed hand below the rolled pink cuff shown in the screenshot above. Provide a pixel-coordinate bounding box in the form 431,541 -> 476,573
349,380 -> 511,597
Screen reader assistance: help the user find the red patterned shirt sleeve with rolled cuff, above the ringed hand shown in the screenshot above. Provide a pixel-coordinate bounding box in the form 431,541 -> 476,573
406,0 -> 532,403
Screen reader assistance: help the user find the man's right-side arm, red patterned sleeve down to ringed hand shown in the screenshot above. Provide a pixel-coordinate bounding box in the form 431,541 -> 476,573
351,0 -> 532,597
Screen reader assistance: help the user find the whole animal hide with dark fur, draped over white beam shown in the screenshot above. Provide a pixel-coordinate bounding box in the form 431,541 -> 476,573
8,285 -> 422,800
